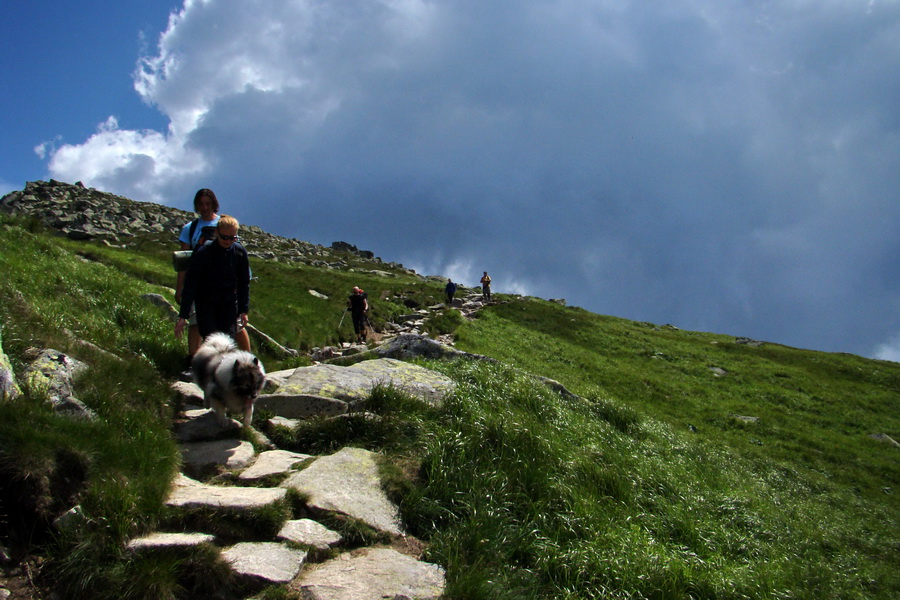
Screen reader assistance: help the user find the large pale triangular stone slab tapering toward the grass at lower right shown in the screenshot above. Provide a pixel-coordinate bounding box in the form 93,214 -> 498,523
281,448 -> 404,535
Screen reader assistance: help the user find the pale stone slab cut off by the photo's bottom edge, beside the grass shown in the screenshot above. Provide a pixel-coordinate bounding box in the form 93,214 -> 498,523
297,548 -> 446,600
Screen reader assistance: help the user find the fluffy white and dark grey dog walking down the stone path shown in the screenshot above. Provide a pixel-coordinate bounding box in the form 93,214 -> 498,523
191,333 -> 266,427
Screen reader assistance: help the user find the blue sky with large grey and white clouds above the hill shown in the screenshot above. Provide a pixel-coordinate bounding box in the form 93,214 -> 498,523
0,0 -> 900,361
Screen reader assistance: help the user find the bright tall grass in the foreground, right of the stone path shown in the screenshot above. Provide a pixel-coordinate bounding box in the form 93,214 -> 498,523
298,362 -> 900,599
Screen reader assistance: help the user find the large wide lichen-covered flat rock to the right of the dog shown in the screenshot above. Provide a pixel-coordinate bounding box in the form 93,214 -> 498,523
275,358 -> 455,408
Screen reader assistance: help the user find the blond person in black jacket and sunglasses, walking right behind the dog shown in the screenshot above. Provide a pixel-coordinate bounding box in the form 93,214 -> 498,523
175,215 -> 250,339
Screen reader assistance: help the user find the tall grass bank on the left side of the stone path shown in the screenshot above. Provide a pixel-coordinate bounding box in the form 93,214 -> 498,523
0,218 -> 182,598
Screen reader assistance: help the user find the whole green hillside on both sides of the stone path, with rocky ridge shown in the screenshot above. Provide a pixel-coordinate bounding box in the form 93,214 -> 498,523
0,182 -> 900,599
